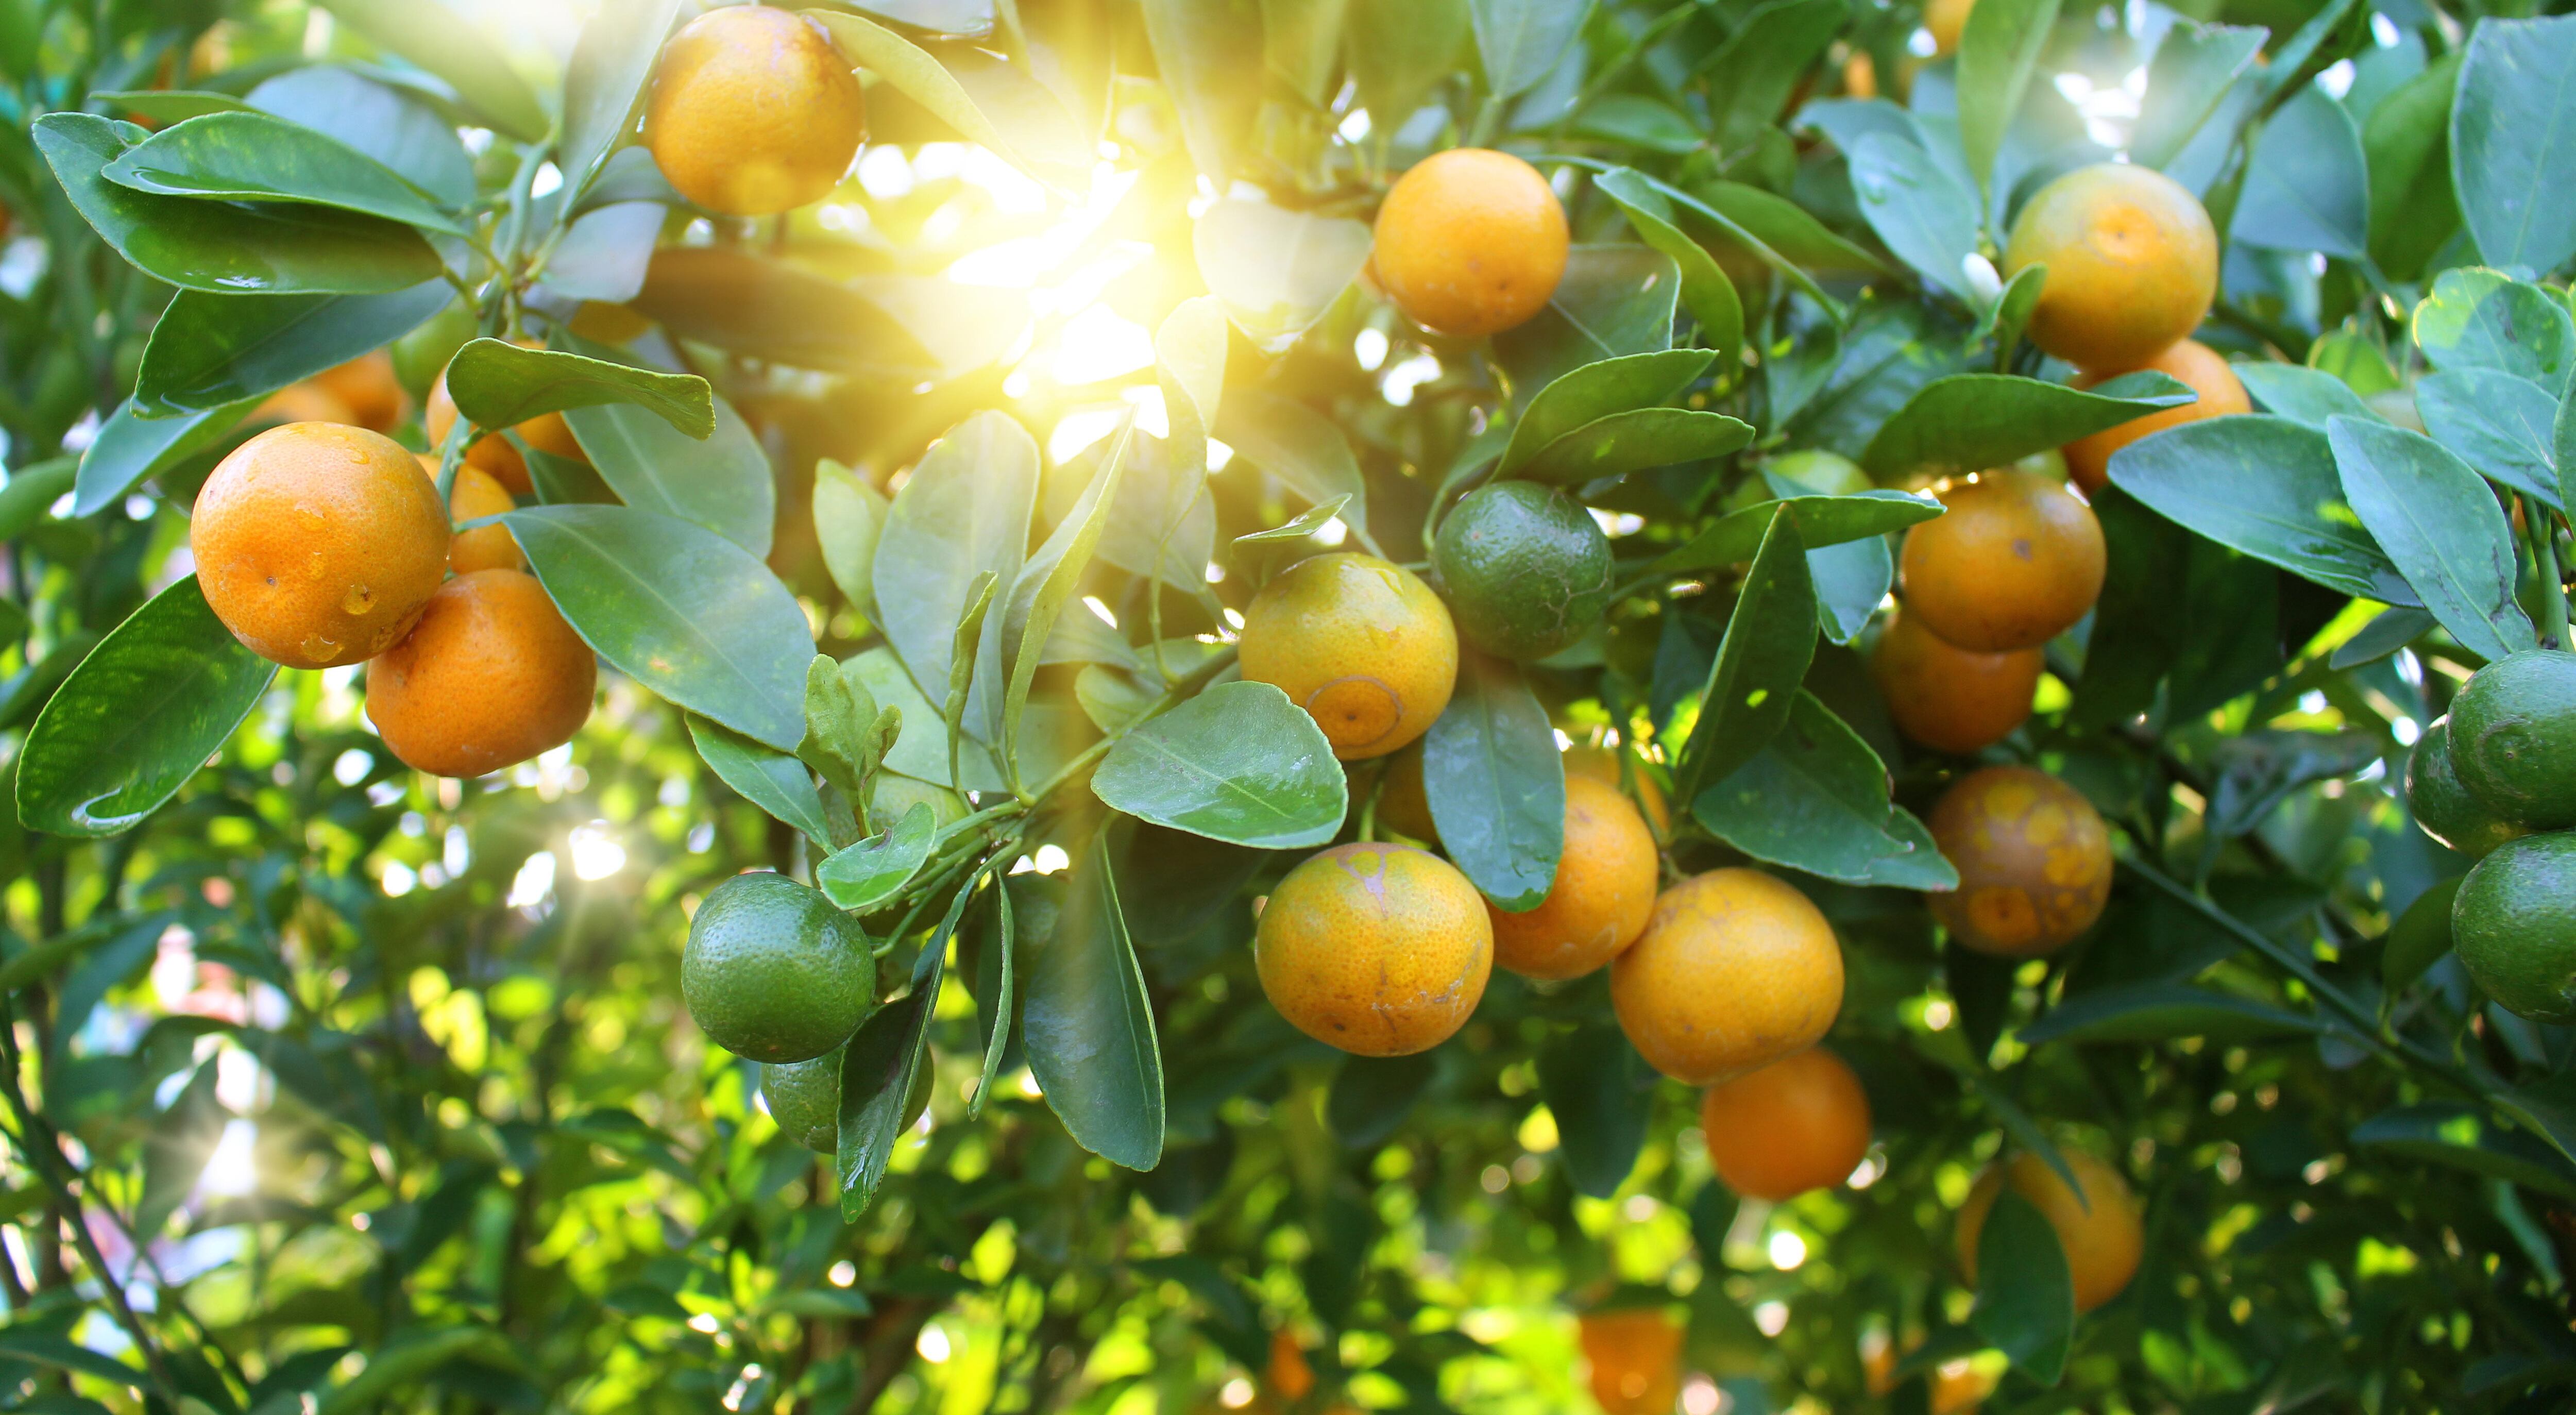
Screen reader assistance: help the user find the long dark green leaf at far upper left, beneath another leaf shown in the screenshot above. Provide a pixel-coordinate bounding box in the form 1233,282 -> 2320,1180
33,113 -> 446,294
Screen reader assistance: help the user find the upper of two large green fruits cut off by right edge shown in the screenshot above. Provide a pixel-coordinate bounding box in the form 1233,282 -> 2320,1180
2450,649 -> 2576,830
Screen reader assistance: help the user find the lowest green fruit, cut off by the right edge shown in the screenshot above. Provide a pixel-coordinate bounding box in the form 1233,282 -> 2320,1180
2450,833 -> 2576,1023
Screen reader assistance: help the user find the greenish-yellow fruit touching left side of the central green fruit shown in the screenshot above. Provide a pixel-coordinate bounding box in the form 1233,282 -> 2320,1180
1236,551 -> 1458,761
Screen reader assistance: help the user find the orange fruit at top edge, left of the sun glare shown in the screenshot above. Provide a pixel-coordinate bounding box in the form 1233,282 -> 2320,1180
644,5 -> 868,216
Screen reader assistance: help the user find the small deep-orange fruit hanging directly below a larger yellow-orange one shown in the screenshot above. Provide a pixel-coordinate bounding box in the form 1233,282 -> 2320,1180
1700,1047 -> 1870,1204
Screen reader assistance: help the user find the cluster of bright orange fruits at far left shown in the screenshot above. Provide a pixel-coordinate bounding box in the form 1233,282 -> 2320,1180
188,353 -> 598,776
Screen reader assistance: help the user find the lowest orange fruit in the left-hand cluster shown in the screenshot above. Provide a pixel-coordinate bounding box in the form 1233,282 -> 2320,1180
366,569 -> 600,776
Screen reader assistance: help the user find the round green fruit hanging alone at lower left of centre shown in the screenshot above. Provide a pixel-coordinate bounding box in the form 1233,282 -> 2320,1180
680,871 -> 876,1065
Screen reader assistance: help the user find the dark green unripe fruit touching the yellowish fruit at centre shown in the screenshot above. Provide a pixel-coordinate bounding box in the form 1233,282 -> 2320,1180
1432,482 -> 1613,657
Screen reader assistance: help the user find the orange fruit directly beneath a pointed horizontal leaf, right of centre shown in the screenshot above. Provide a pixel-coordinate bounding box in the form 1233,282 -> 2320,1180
1896,471 -> 2105,654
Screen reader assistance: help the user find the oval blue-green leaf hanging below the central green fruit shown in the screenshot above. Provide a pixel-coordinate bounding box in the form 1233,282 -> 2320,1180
1422,649 -> 1566,913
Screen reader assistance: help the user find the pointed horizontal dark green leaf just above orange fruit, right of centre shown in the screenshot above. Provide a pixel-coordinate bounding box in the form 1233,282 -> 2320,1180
1860,371 -> 2197,479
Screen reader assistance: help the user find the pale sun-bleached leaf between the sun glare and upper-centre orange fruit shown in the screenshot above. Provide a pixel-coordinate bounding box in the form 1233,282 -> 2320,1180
1190,196 -> 1370,353
